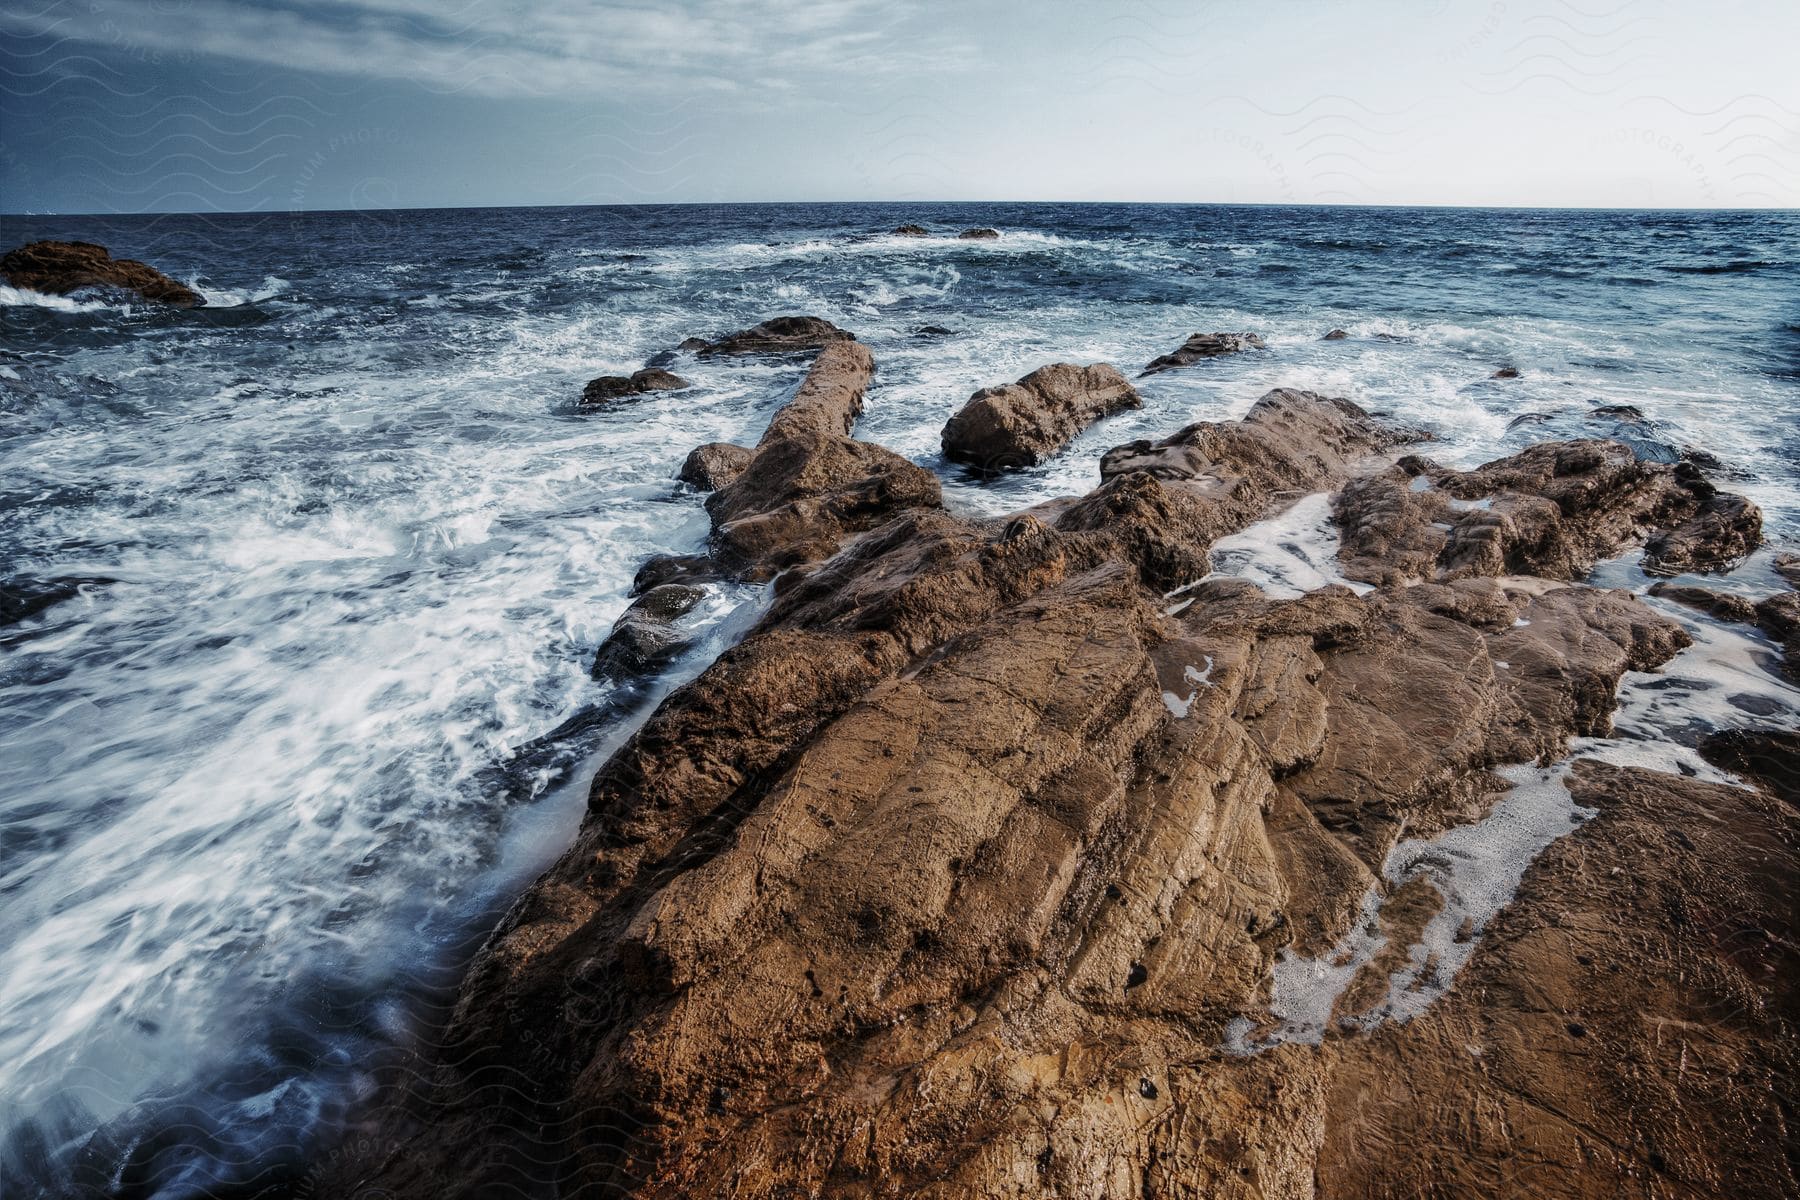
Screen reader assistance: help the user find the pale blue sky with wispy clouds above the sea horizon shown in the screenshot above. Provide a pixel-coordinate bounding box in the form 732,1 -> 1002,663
0,0 -> 1800,212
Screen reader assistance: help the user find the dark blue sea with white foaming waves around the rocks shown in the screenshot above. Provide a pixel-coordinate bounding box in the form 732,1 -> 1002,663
0,205 -> 1800,1196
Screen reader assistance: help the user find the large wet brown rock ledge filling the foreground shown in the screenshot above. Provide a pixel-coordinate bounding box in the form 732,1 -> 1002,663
331,331 -> 1800,1198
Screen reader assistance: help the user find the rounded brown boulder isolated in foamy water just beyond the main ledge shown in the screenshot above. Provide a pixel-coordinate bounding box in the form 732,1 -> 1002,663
943,363 -> 1143,473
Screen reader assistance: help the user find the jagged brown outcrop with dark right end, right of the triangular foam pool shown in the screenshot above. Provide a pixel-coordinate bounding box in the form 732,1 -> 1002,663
1336,441 -> 1762,585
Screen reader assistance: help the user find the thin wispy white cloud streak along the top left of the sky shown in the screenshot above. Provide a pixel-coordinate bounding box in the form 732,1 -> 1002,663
0,0 -> 967,95
